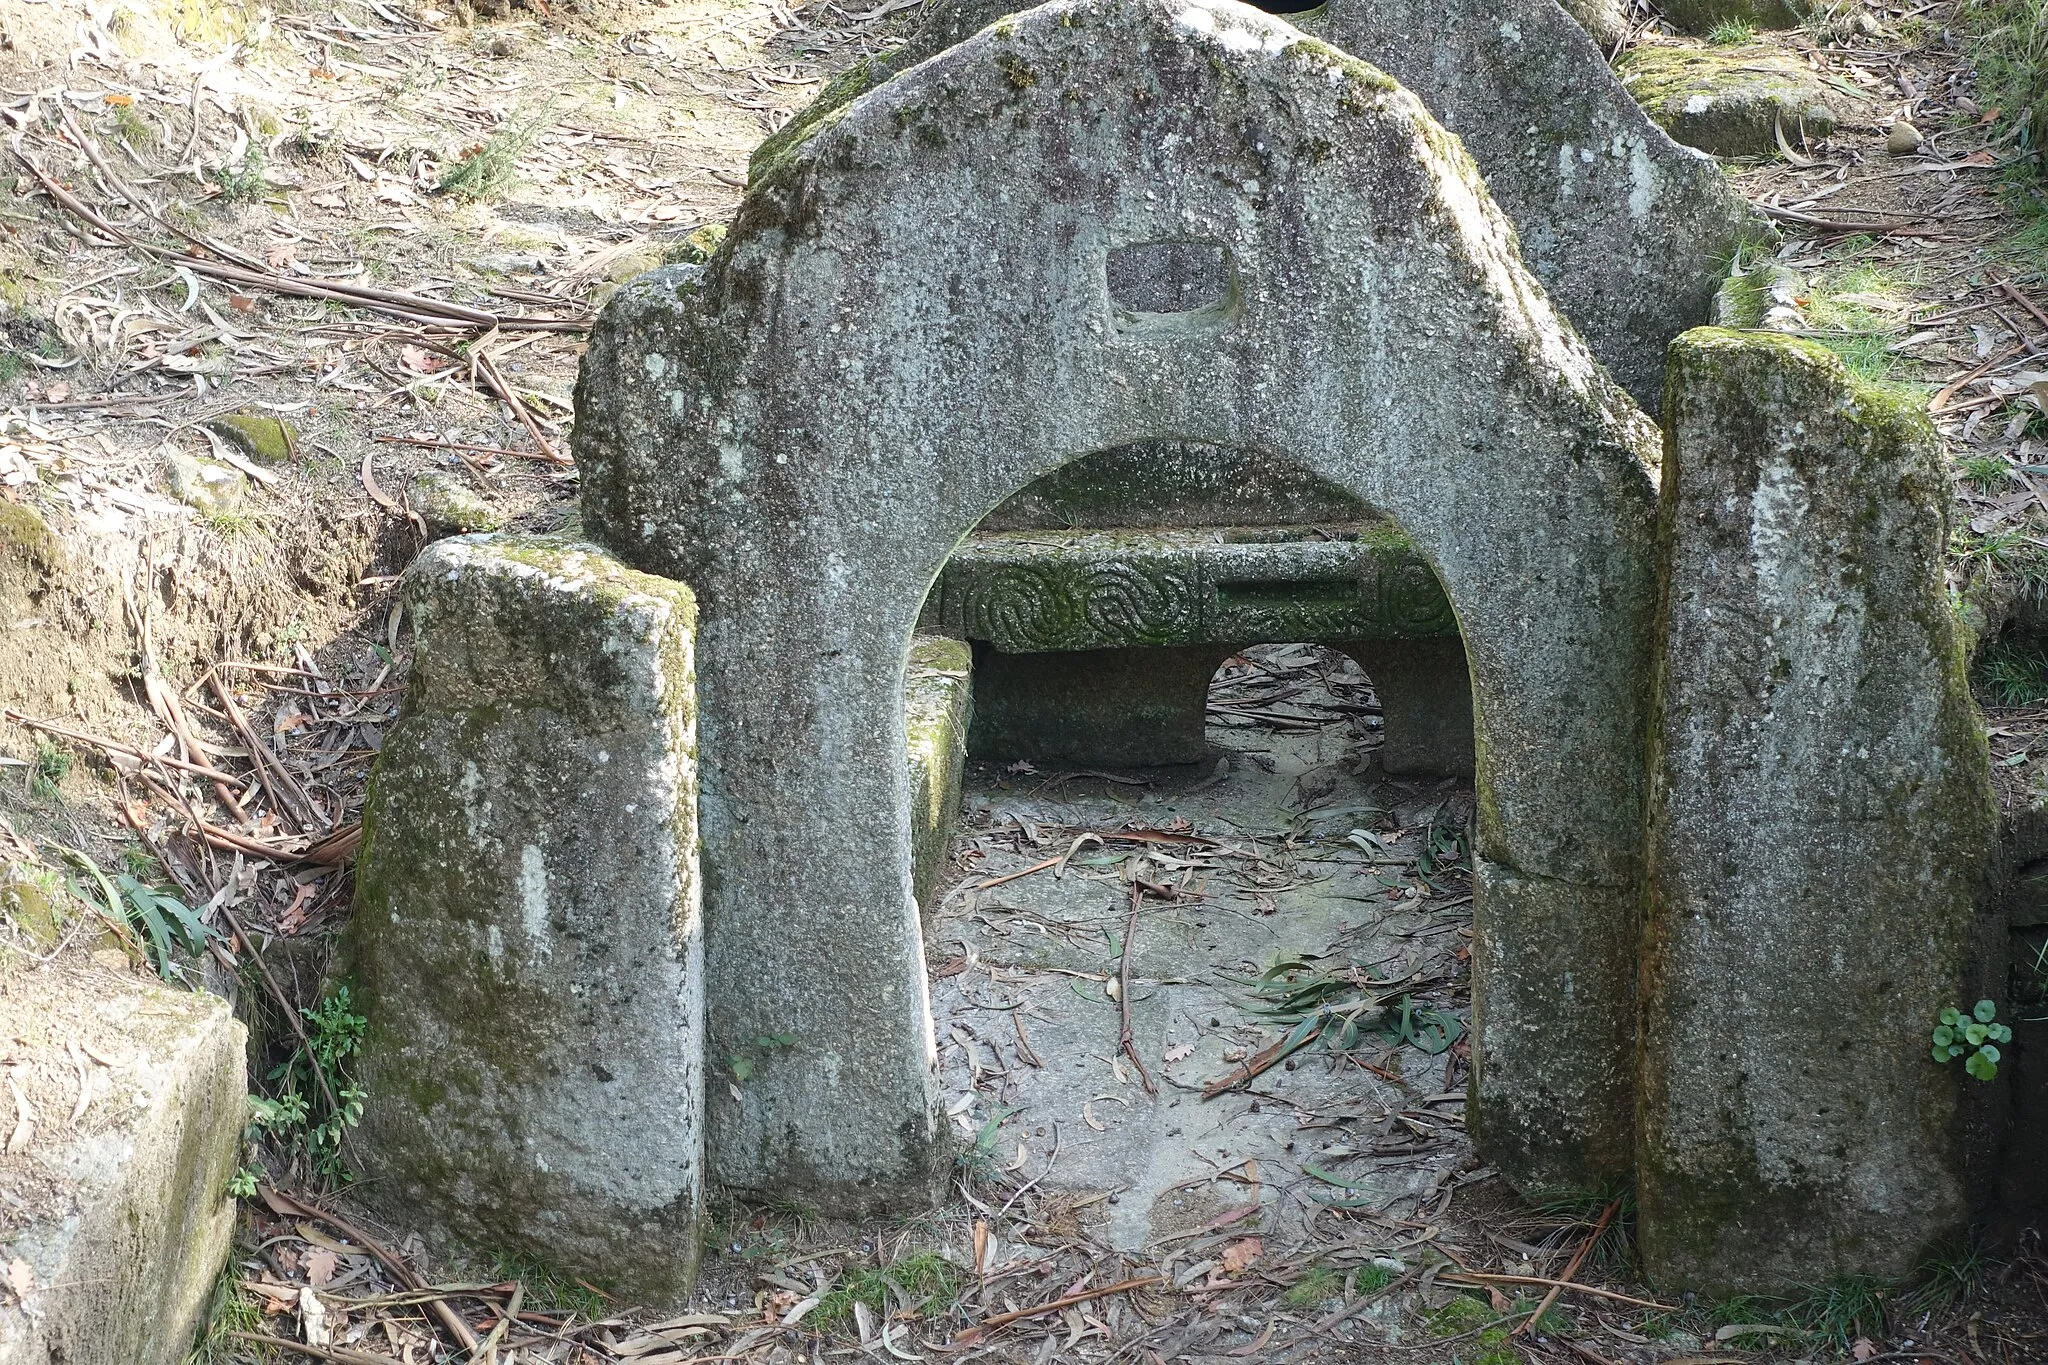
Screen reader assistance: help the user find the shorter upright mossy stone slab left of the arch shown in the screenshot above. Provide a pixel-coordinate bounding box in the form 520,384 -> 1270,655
350,536 -> 708,1302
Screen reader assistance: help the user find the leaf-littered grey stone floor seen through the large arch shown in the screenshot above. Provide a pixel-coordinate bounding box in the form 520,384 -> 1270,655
928,645 -> 1481,1250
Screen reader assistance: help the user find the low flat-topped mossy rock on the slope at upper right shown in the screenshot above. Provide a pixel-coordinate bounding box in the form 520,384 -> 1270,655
1616,45 -> 1835,156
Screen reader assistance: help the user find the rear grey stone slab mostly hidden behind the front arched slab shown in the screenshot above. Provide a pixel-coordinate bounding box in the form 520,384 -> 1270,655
754,0 -> 1772,409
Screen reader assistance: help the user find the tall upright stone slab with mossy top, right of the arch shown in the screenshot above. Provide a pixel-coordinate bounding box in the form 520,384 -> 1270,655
1638,329 -> 1993,1293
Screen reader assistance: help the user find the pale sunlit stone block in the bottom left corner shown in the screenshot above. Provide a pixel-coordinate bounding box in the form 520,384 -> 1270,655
0,964 -> 248,1365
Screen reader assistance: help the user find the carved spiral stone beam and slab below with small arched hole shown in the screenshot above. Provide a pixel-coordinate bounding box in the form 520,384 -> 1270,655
920,522 -> 1473,776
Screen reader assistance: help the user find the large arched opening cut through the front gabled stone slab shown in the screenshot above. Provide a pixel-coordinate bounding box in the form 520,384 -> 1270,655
907,442 -> 1475,1248
